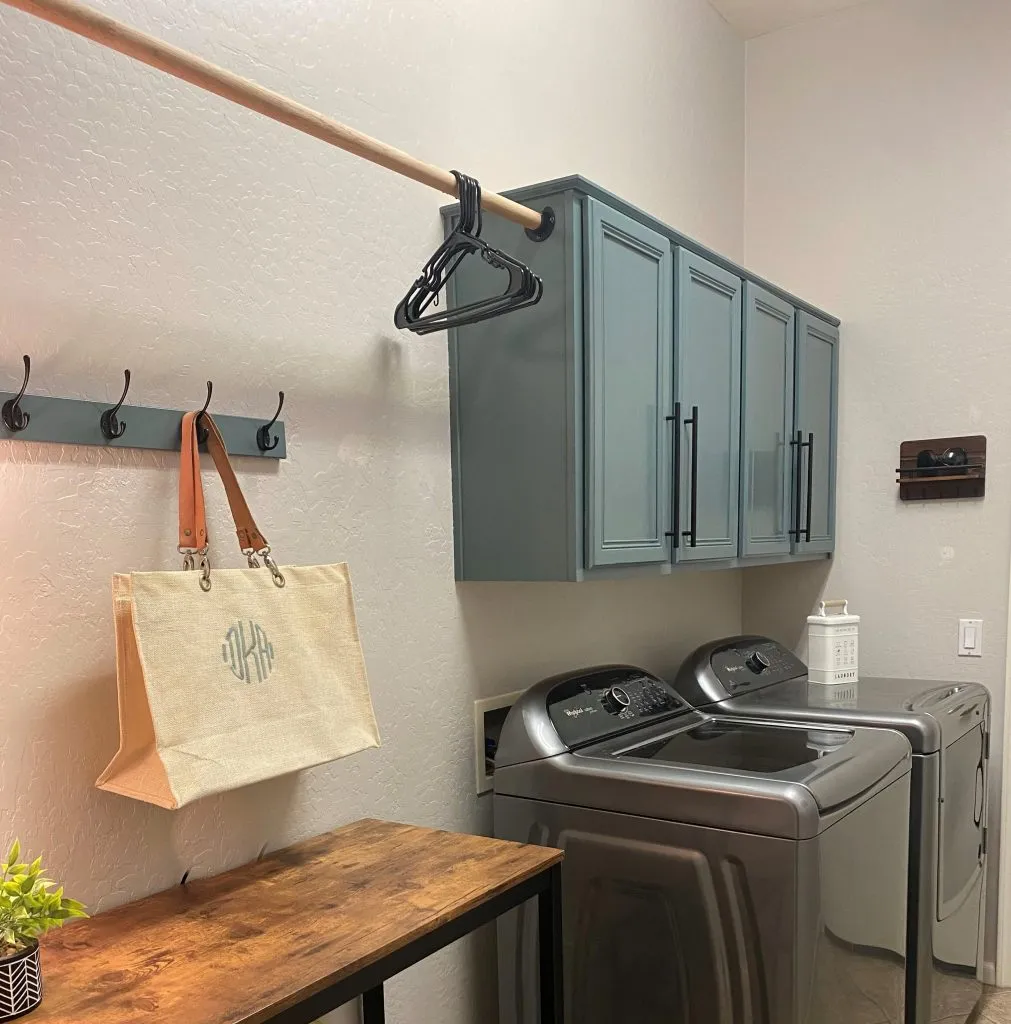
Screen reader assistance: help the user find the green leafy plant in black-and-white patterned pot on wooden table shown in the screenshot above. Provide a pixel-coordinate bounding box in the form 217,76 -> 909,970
0,840 -> 87,1021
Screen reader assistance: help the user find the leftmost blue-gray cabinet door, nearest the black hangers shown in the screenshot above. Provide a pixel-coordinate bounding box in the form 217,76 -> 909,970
586,199 -> 673,568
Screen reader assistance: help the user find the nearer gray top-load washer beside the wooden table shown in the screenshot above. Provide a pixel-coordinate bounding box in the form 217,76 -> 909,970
495,666 -> 911,1024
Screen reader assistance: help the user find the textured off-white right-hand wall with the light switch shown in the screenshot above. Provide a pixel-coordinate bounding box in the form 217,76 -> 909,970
744,0 -> 1011,955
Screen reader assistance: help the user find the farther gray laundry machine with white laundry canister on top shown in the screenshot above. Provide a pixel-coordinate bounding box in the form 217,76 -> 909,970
674,636 -> 989,1024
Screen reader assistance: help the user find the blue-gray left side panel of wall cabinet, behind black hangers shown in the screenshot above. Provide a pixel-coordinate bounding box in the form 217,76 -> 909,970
446,188 -> 584,580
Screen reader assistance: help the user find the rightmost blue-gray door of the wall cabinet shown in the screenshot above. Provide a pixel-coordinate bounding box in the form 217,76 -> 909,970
794,312 -> 839,553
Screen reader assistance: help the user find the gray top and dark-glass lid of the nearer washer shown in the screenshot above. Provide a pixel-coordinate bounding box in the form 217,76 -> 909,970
495,713 -> 911,840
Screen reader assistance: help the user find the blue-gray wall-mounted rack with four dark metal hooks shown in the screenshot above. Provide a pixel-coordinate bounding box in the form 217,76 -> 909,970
0,355 -> 288,459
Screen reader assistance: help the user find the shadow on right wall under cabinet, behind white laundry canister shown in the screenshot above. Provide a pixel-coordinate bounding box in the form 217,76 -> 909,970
741,559 -> 841,662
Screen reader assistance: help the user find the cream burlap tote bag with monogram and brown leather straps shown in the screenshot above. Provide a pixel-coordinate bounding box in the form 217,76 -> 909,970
96,413 -> 379,808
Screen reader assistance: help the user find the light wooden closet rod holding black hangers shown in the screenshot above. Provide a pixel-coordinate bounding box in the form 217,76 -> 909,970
0,0 -> 541,230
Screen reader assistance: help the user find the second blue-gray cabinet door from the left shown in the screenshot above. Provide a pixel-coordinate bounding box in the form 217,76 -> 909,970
674,249 -> 741,562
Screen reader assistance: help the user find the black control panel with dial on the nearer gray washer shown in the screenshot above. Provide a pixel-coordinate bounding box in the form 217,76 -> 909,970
546,666 -> 688,749
